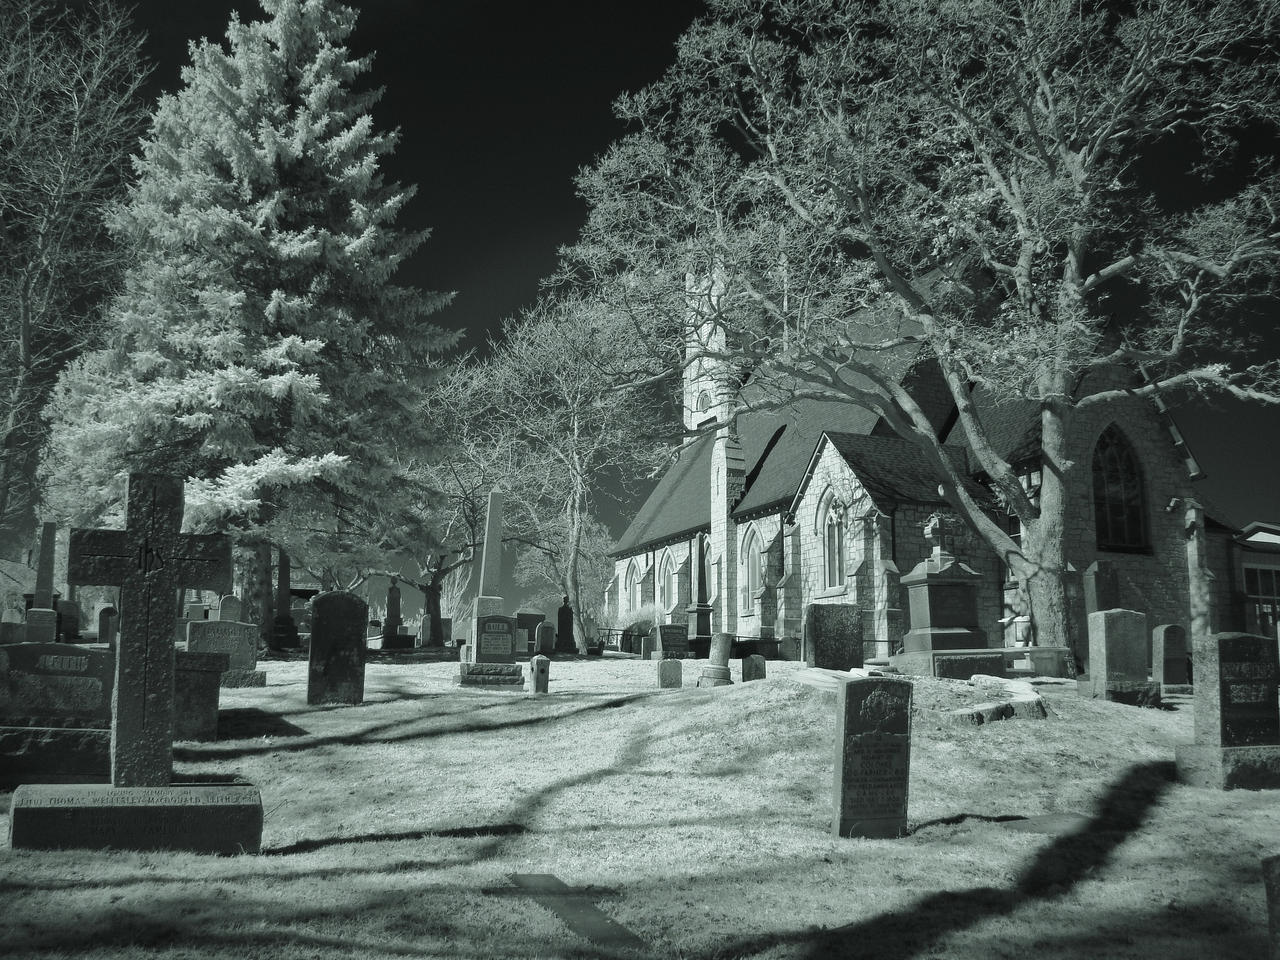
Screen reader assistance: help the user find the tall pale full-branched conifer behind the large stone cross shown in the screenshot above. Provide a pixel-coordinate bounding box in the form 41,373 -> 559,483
45,0 -> 456,570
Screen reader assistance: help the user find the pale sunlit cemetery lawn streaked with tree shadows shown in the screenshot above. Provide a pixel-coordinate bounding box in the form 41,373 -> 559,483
0,657 -> 1280,960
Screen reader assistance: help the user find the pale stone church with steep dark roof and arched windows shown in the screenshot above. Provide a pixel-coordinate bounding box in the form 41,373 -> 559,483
607,343 -> 1280,658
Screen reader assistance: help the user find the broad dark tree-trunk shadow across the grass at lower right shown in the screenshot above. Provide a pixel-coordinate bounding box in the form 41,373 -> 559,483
709,762 -> 1174,960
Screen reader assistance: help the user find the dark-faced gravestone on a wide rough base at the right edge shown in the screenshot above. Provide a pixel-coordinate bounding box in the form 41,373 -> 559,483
1175,634 -> 1280,790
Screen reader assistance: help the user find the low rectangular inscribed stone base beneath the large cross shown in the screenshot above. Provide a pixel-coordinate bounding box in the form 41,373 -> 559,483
9,783 -> 262,855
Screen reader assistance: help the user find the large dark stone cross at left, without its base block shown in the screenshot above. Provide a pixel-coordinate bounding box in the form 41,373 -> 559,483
67,474 -> 232,787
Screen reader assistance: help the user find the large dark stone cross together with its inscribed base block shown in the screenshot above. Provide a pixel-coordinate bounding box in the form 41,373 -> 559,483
9,474 -> 262,852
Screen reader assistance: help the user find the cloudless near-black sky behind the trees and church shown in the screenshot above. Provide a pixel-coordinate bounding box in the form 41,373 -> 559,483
122,0 -> 1280,524
